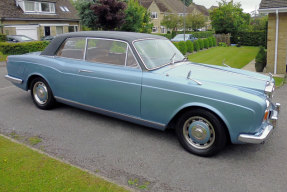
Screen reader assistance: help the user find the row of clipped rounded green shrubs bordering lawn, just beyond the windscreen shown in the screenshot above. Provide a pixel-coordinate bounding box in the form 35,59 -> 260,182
173,37 -> 217,55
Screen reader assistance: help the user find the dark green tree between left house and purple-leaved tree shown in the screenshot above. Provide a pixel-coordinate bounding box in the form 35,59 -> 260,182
74,0 -> 99,30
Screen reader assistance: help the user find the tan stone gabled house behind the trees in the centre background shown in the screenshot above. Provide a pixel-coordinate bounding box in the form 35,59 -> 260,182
138,0 -> 209,33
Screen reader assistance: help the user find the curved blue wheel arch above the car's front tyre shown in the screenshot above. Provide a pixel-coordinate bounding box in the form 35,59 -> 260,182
167,103 -> 231,142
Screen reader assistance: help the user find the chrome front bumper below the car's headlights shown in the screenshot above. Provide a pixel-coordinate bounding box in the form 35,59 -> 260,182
238,103 -> 280,144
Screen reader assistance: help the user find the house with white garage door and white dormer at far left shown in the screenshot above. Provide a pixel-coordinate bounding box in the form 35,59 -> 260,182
0,0 -> 80,40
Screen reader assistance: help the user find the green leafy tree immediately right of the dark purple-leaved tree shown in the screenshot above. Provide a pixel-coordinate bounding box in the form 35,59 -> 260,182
121,0 -> 152,33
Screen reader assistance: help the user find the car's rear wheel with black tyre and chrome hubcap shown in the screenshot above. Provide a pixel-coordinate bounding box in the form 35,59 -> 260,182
30,77 -> 56,110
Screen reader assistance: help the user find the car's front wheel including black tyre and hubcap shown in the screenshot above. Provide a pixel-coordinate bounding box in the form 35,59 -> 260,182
176,109 -> 227,157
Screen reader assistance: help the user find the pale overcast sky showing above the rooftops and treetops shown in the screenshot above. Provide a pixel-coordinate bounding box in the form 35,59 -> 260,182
193,0 -> 261,13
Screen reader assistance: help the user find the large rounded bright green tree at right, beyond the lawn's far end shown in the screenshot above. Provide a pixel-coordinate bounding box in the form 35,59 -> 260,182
210,0 -> 250,34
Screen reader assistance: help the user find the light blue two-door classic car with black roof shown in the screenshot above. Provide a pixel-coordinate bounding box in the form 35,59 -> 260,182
6,31 -> 280,156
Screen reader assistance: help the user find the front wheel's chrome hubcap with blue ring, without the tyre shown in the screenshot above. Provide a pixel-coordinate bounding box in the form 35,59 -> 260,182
183,116 -> 215,149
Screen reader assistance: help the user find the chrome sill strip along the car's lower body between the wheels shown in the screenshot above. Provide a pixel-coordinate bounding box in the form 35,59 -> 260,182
54,96 -> 166,128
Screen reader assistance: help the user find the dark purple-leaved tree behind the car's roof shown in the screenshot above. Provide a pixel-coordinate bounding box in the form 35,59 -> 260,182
91,0 -> 126,30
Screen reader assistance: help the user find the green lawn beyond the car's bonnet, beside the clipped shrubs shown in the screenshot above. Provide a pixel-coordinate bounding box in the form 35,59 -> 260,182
188,46 -> 259,69
